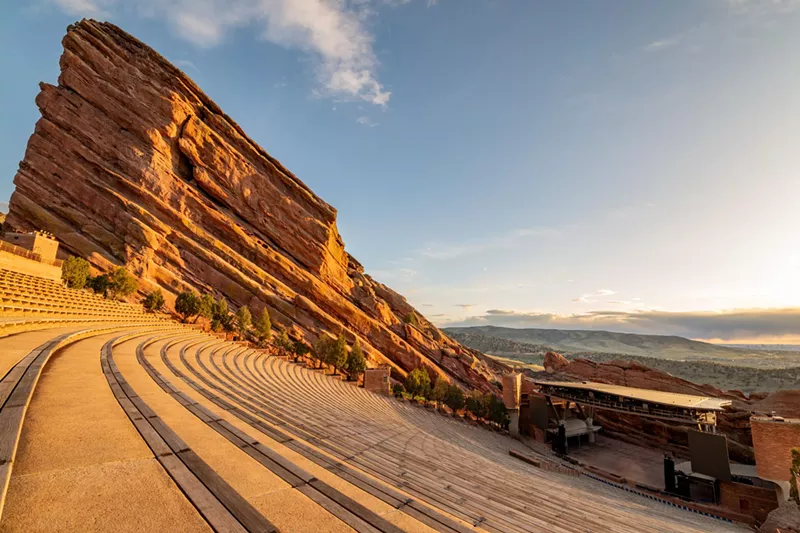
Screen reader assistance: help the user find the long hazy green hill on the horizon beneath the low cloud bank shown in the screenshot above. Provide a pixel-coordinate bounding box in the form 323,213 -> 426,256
445,326 -> 800,361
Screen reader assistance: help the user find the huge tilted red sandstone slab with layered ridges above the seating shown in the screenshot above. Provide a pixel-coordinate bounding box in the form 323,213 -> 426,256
7,20 -> 496,391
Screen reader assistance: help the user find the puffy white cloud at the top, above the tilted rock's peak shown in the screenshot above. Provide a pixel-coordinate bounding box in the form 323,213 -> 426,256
50,0 -> 404,107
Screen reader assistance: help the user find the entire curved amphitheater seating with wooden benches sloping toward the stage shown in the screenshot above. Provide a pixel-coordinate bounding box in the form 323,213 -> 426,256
0,272 -> 747,533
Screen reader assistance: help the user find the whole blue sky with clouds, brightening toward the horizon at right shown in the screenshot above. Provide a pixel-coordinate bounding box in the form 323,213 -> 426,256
0,0 -> 800,342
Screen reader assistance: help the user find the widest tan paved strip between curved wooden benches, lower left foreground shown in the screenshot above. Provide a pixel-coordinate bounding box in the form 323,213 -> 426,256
0,331 -> 210,533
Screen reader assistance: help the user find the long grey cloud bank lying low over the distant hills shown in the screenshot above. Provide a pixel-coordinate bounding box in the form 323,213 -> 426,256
440,308 -> 800,340
